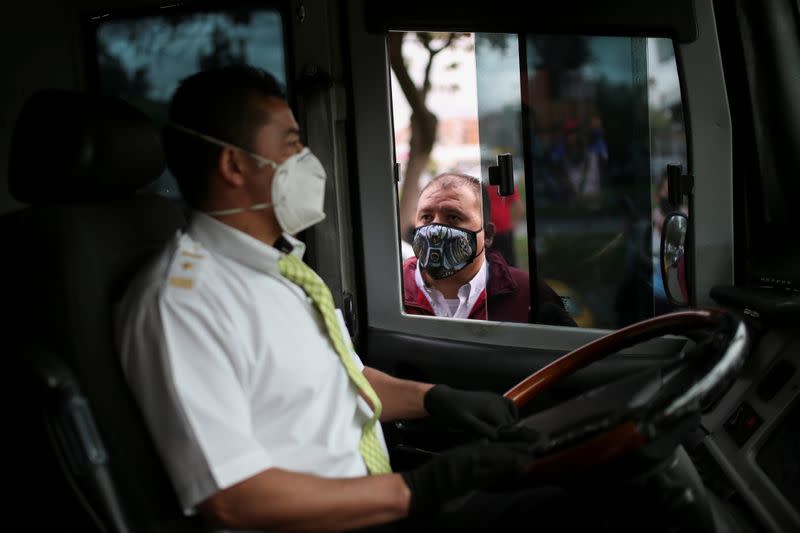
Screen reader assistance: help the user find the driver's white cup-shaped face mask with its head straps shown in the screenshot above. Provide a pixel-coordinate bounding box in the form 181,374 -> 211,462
170,123 -> 327,235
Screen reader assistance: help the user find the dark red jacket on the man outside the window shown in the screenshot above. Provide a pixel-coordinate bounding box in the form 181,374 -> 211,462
403,249 -> 564,322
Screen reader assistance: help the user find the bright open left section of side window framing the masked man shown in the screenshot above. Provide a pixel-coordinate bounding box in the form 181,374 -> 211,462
388,32 -> 496,319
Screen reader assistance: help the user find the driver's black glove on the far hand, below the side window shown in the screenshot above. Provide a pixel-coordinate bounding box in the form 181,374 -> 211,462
423,385 -> 518,440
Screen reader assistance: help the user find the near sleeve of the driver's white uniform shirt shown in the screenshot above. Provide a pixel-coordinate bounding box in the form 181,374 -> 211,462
122,282 -> 273,513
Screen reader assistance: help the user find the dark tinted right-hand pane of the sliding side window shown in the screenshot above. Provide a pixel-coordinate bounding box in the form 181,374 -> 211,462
526,36 -> 686,328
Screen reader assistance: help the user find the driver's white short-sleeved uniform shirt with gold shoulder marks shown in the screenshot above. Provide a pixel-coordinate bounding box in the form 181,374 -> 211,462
117,213 -> 386,513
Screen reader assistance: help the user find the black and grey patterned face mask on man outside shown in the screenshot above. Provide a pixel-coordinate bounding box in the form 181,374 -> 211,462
412,224 -> 483,279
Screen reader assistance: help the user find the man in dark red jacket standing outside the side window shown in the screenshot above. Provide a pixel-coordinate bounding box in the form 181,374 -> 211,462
403,173 -> 575,326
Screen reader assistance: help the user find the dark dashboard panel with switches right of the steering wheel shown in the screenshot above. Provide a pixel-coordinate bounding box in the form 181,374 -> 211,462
692,328 -> 800,532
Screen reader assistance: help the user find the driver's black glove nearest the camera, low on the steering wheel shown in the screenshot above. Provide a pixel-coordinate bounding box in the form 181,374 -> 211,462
402,441 -> 534,516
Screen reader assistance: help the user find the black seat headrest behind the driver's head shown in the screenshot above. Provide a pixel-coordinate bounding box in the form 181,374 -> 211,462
8,89 -> 164,204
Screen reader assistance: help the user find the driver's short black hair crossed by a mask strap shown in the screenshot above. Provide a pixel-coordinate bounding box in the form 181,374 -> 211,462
164,65 -> 286,207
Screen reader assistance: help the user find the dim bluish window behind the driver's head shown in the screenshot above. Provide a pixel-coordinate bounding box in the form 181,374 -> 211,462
93,8 -> 286,198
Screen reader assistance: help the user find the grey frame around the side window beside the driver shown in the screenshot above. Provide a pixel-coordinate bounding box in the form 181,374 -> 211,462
348,0 -> 733,355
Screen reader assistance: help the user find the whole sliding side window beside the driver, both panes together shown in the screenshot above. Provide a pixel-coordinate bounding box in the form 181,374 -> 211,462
388,32 -> 686,329
